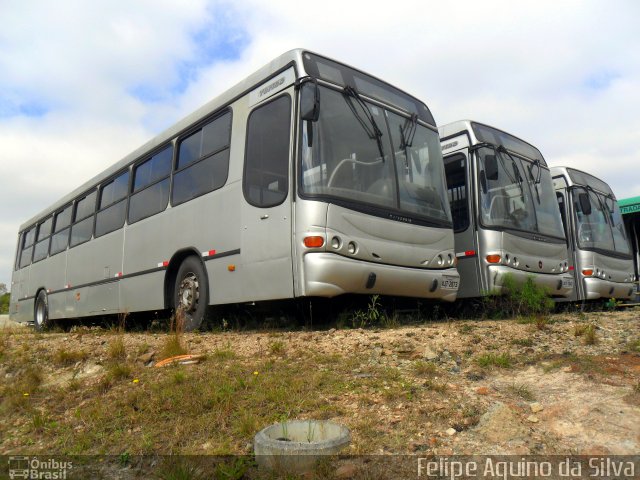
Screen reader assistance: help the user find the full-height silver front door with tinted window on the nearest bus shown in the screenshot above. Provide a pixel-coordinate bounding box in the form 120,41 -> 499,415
240,89 -> 293,300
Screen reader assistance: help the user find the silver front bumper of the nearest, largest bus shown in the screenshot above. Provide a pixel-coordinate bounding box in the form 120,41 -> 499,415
303,252 -> 460,302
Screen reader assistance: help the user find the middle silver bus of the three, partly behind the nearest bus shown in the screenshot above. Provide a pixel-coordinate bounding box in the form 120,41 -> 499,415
439,120 -> 573,298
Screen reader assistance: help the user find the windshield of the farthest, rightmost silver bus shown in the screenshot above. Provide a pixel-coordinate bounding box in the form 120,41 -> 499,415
571,187 -> 630,254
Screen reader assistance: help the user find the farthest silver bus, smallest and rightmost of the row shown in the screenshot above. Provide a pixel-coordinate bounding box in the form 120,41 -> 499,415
551,167 -> 635,300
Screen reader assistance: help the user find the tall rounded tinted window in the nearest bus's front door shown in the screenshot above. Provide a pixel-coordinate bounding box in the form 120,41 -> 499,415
243,95 -> 291,207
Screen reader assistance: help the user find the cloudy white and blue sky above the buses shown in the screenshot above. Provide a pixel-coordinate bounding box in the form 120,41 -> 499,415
0,0 -> 640,286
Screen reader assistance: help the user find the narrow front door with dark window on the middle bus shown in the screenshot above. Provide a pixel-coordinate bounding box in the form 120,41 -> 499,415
444,153 -> 481,298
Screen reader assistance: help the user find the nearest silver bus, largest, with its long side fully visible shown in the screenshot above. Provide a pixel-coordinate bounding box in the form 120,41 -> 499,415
10,49 -> 459,329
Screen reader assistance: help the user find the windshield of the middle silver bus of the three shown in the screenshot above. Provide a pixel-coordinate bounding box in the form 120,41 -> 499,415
477,146 -> 564,238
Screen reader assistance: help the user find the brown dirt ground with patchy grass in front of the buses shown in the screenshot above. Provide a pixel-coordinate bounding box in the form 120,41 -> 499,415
0,309 -> 640,464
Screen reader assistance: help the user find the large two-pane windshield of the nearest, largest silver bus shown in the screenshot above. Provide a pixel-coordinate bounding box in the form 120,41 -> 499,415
301,86 -> 451,227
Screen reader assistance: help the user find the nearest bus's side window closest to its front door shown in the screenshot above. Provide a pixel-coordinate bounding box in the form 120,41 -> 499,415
171,112 -> 231,205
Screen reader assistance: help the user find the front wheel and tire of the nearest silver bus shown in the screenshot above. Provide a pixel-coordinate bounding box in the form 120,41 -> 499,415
173,256 -> 209,332
